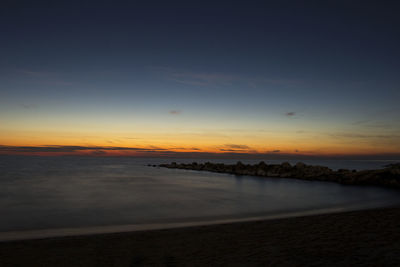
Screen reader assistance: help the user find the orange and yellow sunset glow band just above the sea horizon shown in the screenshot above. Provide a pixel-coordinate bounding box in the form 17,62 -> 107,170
0,124 -> 400,157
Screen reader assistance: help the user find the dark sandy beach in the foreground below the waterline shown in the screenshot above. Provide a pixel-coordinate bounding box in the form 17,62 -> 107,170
0,207 -> 400,266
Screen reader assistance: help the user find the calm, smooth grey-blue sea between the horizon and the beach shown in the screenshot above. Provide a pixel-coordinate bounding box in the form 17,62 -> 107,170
0,156 -> 400,231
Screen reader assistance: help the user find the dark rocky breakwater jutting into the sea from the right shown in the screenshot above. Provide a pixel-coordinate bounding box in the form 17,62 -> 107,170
156,161 -> 400,189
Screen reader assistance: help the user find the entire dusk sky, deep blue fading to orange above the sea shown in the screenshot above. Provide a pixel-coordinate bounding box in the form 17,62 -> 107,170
0,1 -> 400,158
